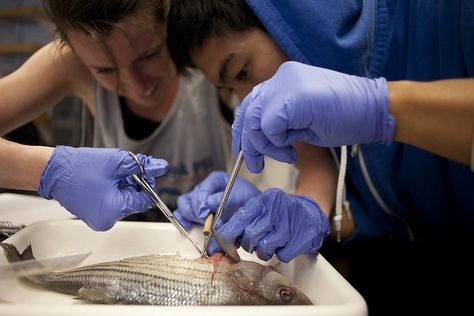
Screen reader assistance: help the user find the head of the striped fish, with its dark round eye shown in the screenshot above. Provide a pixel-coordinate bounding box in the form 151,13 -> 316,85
232,261 -> 313,305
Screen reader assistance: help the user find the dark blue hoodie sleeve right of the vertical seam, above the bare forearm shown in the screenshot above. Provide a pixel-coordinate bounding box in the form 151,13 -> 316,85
381,0 -> 474,81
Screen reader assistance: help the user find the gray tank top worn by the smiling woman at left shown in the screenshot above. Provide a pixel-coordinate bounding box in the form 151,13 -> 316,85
93,71 -> 231,210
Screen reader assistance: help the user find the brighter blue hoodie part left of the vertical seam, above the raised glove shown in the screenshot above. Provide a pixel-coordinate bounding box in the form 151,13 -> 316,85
247,0 -> 387,76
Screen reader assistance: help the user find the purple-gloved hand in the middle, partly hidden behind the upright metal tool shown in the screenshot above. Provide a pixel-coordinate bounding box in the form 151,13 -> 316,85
173,171 -> 260,229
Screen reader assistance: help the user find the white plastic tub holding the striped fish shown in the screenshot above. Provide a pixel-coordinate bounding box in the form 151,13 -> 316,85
0,196 -> 367,316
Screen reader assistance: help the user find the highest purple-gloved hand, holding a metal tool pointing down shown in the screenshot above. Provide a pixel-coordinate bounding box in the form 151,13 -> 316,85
232,62 -> 395,172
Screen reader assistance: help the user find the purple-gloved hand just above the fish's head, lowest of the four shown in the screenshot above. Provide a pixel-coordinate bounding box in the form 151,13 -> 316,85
208,189 -> 330,263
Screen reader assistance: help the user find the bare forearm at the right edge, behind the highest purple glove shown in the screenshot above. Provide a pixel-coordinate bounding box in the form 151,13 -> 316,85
388,79 -> 474,165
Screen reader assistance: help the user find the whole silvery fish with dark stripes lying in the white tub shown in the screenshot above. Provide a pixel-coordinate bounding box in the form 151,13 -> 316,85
0,243 -> 313,306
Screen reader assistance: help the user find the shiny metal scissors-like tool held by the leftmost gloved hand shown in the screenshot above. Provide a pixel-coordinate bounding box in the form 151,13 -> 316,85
128,151 -> 203,254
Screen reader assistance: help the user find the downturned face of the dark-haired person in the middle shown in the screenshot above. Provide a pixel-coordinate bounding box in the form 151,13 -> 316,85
192,29 -> 288,100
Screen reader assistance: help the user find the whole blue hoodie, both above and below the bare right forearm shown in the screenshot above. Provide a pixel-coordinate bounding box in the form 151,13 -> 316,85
247,0 -> 474,241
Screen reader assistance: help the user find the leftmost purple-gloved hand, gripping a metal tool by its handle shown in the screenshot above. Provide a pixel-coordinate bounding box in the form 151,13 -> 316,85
38,146 -> 168,230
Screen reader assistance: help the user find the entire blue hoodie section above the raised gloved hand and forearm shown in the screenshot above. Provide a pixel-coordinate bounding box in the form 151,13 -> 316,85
247,0 -> 474,80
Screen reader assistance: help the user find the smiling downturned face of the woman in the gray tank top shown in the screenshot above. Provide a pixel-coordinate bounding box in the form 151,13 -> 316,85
66,10 -> 176,107
